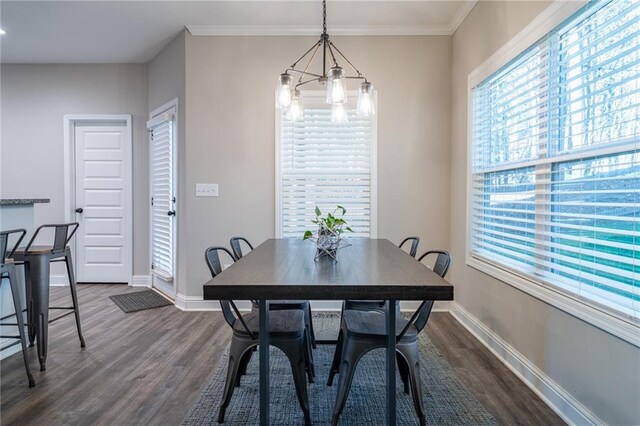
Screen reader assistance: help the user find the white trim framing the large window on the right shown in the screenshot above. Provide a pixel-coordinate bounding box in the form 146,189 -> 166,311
465,0 -> 640,347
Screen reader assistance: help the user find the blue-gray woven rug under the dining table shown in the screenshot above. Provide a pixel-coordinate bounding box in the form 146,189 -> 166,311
182,314 -> 496,426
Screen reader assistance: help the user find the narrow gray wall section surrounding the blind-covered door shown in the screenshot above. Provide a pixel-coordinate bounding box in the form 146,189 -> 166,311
147,31 -> 188,294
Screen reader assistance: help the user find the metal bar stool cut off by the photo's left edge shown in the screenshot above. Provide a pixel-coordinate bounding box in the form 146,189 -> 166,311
0,229 -> 36,388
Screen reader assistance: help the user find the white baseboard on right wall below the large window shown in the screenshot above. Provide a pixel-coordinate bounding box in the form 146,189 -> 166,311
449,302 -> 604,425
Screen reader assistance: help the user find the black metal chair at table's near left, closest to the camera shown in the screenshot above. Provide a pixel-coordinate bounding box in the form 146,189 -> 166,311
205,247 -> 311,424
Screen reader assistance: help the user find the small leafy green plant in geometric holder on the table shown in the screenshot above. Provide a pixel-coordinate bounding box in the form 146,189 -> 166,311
303,206 -> 353,260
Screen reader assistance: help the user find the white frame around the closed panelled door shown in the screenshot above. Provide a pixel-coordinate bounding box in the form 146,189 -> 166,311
62,114 -> 133,286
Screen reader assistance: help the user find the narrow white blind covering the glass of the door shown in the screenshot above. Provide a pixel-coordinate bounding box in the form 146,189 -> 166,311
148,114 -> 175,280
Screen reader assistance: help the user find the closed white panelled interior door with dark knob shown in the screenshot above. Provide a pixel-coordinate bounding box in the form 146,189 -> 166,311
75,122 -> 132,283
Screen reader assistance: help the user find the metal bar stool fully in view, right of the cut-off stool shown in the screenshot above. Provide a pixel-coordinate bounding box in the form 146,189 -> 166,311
14,222 -> 85,371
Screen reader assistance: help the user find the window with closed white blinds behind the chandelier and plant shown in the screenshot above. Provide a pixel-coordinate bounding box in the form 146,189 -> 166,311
276,91 -> 377,238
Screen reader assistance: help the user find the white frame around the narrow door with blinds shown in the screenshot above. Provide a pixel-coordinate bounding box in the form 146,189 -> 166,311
147,98 -> 180,301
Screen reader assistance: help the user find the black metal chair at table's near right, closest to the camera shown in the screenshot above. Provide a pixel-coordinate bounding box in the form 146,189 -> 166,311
327,250 -> 451,425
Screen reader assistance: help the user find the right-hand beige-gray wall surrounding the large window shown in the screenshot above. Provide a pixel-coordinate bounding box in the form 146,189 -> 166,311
450,2 -> 640,425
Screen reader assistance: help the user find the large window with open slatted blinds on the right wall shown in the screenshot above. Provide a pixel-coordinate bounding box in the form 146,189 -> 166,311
468,0 -> 640,326
